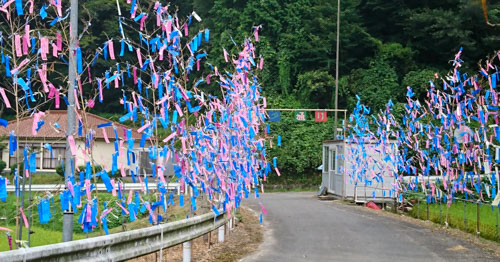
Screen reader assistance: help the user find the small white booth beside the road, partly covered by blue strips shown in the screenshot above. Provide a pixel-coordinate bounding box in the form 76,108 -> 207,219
321,140 -> 398,203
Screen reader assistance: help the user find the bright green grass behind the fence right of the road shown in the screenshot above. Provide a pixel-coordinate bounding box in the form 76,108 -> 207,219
409,201 -> 500,242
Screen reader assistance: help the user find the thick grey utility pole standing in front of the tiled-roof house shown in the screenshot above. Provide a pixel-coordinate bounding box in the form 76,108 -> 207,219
63,0 -> 78,242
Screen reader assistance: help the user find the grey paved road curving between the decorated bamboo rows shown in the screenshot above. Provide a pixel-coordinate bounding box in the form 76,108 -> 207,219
242,193 -> 500,262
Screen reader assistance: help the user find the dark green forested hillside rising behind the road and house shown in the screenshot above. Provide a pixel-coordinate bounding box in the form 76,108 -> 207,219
3,0 -> 500,183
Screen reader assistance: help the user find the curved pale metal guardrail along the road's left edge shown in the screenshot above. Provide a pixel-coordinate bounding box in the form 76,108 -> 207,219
0,211 -> 228,262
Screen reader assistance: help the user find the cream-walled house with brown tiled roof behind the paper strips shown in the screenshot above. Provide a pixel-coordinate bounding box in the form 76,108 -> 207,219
0,110 -> 151,172
